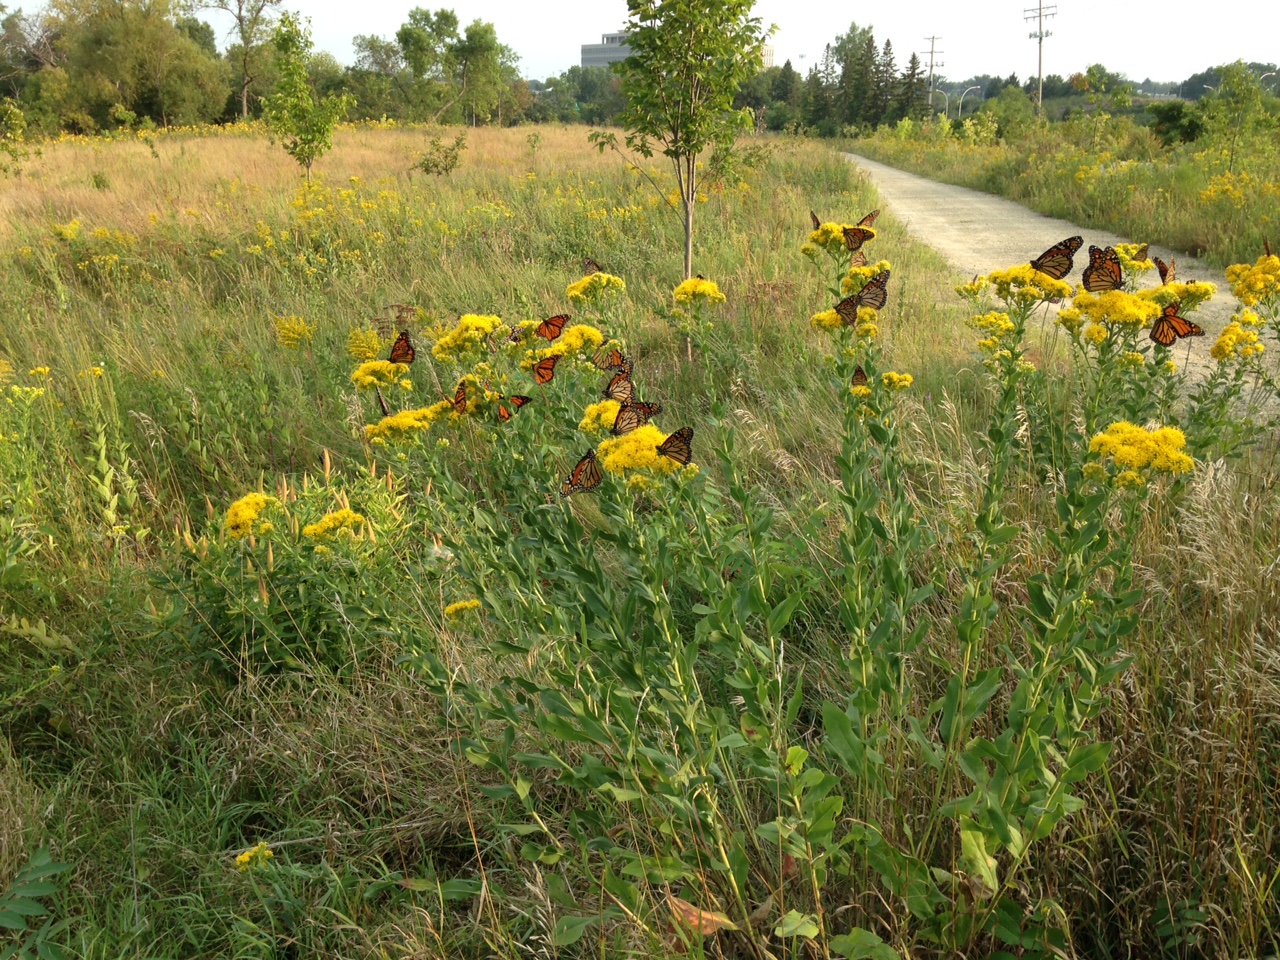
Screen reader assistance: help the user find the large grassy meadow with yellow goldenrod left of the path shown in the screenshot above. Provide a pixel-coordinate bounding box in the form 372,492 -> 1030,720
0,128 -> 1280,957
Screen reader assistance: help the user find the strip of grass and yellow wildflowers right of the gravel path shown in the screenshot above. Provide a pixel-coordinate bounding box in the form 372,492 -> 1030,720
851,111 -> 1280,266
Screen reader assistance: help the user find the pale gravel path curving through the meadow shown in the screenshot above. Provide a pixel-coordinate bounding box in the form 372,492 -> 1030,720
844,154 -> 1235,361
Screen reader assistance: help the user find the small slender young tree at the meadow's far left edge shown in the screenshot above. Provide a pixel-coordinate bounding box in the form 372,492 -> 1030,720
264,13 -> 351,180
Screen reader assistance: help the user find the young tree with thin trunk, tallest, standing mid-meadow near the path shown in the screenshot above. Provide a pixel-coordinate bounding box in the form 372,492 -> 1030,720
595,0 -> 764,279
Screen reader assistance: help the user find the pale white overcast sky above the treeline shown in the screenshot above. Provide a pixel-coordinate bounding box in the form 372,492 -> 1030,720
247,0 -> 1280,81
